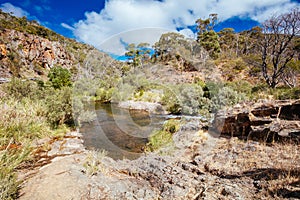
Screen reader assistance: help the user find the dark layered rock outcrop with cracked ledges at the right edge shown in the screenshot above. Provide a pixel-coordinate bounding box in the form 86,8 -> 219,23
213,100 -> 300,141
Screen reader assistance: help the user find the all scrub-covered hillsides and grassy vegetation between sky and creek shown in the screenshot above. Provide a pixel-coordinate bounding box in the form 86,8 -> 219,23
0,10 -> 300,199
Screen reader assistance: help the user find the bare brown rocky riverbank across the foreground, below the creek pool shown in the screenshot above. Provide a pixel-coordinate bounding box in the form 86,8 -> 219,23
20,103 -> 300,200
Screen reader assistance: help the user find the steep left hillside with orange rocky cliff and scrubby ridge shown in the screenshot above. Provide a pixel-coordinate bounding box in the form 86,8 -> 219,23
0,11 -> 112,78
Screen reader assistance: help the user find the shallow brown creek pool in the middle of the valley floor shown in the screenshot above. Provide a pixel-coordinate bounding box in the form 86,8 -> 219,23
80,103 -> 166,159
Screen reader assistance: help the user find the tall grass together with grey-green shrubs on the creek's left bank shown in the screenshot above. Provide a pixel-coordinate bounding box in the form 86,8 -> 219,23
0,79 -> 72,200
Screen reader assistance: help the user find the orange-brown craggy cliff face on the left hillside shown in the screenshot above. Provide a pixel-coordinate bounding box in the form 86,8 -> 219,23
0,29 -> 75,78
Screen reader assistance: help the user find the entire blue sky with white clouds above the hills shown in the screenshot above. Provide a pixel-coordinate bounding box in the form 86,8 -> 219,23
0,0 -> 300,54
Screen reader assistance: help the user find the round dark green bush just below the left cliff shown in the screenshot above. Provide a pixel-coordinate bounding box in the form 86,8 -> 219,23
48,67 -> 72,89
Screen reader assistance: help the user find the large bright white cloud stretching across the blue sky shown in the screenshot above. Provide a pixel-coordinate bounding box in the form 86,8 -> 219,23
71,0 -> 299,53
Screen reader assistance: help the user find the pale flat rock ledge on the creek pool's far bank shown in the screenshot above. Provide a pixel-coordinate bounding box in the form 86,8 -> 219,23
118,101 -> 167,114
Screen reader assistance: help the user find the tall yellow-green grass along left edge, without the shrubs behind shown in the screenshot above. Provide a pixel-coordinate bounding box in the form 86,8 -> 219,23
0,96 -> 54,200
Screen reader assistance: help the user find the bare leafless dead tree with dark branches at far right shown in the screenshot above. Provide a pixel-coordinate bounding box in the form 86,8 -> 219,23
260,9 -> 300,88
